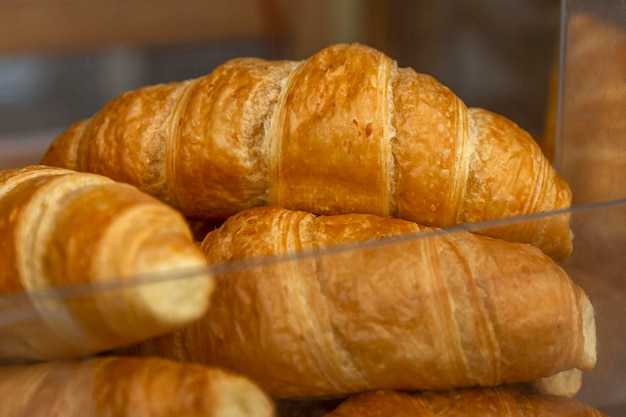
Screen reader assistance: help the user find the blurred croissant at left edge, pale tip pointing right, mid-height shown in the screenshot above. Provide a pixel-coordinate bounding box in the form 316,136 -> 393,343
0,166 -> 213,361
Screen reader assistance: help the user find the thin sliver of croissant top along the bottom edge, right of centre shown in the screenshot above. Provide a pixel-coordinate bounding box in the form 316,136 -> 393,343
327,386 -> 604,417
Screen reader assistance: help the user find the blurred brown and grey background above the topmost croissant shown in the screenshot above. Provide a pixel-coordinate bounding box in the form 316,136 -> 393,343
0,0 -> 560,168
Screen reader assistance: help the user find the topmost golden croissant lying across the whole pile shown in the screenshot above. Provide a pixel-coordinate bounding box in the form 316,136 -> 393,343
42,44 -> 571,259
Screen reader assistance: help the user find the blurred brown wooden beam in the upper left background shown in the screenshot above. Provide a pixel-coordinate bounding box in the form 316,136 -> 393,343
0,0 -> 273,53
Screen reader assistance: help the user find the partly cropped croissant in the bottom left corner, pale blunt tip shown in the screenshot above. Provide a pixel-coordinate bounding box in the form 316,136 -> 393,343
0,357 -> 275,417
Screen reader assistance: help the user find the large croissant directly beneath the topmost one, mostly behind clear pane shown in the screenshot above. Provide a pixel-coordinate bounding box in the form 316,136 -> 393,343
123,206 -> 596,398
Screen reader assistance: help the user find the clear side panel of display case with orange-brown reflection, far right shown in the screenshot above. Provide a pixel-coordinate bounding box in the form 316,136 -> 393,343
556,0 -> 626,416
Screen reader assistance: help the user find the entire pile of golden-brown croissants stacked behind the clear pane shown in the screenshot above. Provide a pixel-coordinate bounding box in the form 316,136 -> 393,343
0,44 -> 602,417
